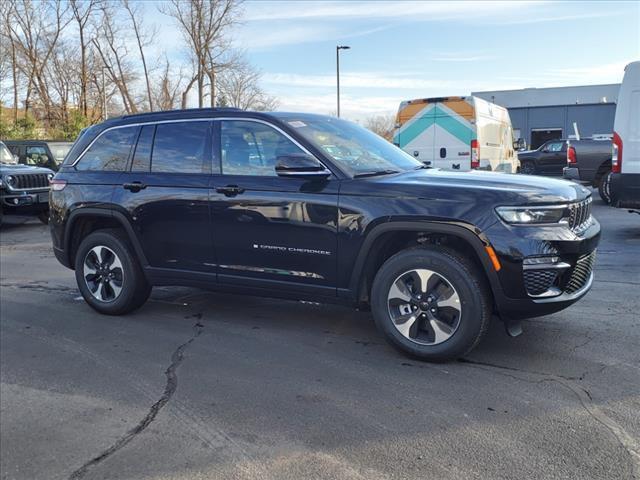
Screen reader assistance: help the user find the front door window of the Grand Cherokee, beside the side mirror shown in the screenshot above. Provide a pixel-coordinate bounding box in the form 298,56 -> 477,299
220,120 -> 304,176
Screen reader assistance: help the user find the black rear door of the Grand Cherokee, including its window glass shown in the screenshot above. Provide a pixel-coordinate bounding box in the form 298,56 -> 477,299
113,120 -> 215,281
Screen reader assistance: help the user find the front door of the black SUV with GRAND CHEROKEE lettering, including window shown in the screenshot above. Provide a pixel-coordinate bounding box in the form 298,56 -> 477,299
210,119 -> 338,296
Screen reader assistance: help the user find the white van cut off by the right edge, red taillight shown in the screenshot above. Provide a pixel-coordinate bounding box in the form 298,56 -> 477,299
610,62 -> 640,208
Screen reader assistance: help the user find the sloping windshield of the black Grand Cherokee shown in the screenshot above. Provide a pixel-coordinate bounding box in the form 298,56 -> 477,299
284,117 -> 424,176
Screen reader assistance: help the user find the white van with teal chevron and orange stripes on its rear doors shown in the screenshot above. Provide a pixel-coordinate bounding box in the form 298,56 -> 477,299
394,96 -> 520,173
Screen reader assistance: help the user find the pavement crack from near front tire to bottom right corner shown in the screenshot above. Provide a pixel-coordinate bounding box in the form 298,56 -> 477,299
458,358 -> 640,480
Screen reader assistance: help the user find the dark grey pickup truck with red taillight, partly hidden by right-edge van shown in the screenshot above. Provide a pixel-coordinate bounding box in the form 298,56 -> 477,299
562,139 -> 611,204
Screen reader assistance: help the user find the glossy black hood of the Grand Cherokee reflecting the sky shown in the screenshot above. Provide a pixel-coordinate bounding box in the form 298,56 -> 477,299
345,169 -> 591,206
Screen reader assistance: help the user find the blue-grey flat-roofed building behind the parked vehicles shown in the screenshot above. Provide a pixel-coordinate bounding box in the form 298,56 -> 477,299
472,84 -> 620,148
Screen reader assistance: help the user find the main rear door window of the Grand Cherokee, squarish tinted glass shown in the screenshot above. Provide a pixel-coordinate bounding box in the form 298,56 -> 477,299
151,122 -> 211,173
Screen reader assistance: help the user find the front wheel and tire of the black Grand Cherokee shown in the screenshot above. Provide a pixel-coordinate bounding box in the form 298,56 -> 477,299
371,247 -> 492,362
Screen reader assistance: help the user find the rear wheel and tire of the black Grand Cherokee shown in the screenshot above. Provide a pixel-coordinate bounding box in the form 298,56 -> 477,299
75,229 -> 151,315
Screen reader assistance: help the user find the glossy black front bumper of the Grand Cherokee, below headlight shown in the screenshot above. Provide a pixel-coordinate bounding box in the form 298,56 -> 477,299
485,219 -> 600,320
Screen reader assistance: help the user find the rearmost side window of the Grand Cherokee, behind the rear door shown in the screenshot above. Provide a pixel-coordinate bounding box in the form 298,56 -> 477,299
76,127 -> 138,172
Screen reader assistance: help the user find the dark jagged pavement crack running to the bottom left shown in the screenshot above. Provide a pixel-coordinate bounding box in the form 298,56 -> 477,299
69,321 -> 204,480
